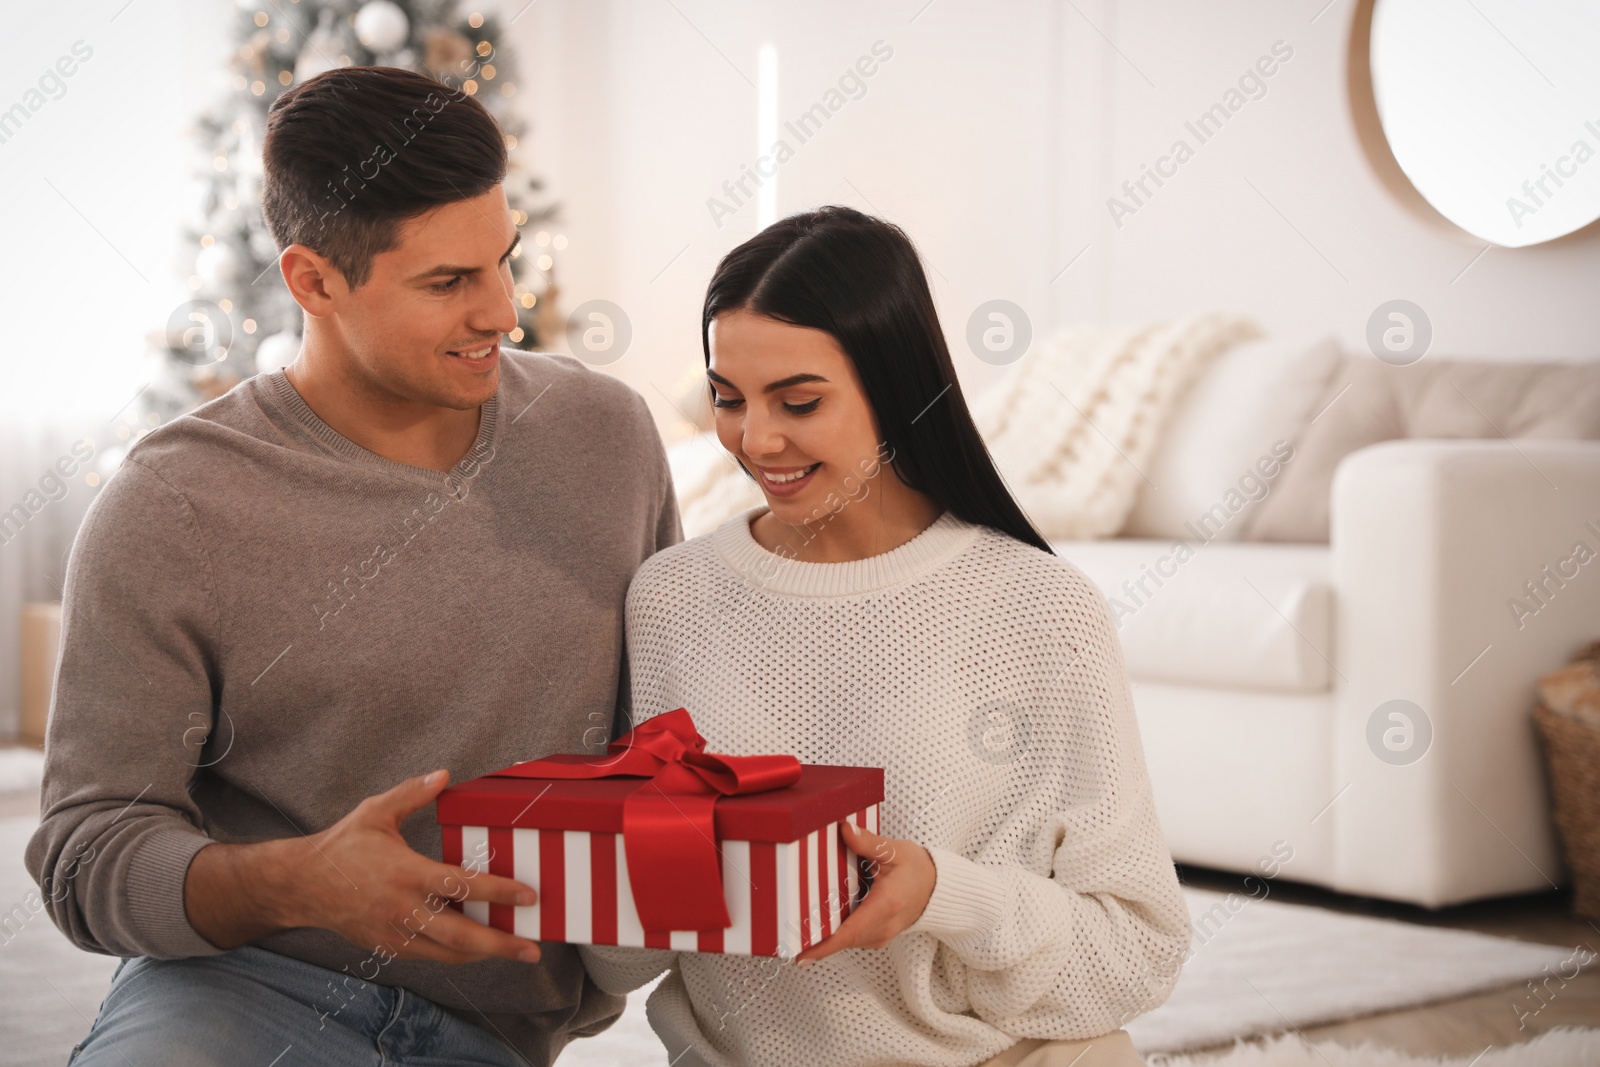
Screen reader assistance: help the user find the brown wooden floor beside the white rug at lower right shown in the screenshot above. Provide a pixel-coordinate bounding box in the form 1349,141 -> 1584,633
1178,865 -> 1600,1056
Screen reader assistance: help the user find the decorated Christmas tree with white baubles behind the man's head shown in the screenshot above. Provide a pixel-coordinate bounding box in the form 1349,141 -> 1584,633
139,0 -> 566,425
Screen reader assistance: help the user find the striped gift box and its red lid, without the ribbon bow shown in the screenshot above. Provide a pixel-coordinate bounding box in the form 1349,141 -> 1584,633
438,765 -> 883,957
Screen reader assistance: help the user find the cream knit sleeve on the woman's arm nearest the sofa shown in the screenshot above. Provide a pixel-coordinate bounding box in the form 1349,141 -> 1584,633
907,571 -> 1189,1038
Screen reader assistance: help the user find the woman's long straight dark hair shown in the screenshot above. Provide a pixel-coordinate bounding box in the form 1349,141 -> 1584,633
701,206 -> 1051,552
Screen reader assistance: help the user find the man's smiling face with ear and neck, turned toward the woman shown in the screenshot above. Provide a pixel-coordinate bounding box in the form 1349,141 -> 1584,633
328,186 -> 518,411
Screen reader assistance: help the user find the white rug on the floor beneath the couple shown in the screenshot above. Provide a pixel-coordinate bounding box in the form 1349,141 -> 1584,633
0,817 -> 1600,1067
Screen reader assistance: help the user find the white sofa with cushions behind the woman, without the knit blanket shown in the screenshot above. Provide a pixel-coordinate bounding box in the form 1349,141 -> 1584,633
669,329 -> 1600,907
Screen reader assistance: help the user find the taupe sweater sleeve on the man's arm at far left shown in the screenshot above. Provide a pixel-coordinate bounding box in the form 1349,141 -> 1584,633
24,458 -> 219,958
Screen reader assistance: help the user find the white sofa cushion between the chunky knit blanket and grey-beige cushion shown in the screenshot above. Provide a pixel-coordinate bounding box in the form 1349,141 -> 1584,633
1122,338 -> 1342,541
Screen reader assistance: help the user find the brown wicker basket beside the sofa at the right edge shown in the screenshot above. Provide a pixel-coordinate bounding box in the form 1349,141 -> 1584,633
1533,704 -> 1600,918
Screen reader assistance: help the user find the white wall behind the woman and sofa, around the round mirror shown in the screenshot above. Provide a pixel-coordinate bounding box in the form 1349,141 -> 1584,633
504,0 -> 1600,435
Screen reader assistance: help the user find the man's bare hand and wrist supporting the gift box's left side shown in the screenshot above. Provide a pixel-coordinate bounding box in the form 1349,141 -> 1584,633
184,771 -> 539,963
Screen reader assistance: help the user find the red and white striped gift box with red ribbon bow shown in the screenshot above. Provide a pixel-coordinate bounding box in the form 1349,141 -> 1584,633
437,709 -> 883,957
